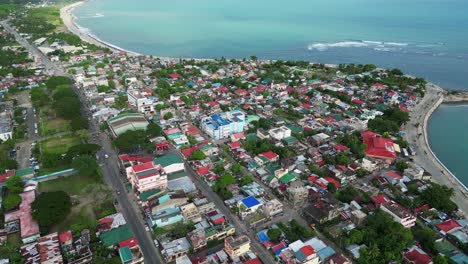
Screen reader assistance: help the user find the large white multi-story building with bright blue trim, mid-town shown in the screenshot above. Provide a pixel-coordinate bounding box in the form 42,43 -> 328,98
200,110 -> 245,140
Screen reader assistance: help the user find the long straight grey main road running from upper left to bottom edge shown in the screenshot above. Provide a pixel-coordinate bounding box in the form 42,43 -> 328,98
0,20 -> 165,264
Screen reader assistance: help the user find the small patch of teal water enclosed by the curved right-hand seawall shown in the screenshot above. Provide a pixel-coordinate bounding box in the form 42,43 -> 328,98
428,104 -> 468,186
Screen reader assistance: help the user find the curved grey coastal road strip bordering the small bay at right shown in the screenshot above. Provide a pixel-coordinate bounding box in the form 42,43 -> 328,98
405,84 -> 468,215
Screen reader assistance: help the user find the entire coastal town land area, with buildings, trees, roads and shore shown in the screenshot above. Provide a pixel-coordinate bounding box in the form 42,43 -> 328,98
0,0 -> 468,264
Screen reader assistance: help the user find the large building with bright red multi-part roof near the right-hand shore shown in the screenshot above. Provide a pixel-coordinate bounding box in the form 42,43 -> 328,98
361,131 -> 397,163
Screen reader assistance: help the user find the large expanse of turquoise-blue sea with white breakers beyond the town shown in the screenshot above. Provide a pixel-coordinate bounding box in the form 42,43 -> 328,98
75,0 -> 468,89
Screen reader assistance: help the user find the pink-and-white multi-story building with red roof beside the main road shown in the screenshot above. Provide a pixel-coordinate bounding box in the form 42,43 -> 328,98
126,161 -> 167,193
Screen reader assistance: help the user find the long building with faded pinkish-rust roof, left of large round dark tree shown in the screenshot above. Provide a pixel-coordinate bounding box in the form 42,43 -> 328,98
5,190 -> 40,244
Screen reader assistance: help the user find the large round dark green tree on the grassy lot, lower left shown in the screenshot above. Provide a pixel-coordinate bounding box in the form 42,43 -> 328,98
32,191 -> 71,234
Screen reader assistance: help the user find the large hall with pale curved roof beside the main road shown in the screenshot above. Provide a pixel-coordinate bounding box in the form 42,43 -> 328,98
107,113 -> 149,137
